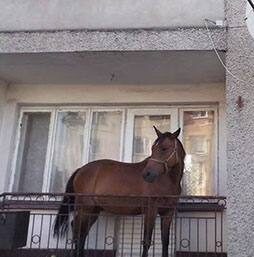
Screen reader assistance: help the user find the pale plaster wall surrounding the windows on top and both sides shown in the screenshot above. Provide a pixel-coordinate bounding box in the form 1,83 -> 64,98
0,84 -> 226,195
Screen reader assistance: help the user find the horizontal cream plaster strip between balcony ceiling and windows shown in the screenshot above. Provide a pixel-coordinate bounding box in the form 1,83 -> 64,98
7,84 -> 224,104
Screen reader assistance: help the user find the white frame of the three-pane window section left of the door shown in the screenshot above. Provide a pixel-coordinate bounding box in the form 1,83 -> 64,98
8,106 -> 126,192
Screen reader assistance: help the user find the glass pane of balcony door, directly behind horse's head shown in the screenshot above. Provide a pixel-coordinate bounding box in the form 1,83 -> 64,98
132,115 -> 170,162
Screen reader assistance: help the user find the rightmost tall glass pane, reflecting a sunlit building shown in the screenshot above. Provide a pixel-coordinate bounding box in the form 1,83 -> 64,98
183,111 -> 215,195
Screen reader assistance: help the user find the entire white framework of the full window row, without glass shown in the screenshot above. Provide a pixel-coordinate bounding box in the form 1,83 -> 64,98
8,103 -> 220,195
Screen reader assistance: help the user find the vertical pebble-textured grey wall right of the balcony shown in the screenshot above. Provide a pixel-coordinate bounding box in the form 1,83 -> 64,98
226,0 -> 254,257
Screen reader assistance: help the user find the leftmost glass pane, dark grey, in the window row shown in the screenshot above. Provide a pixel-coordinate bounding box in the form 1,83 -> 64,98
14,112 -> 50,192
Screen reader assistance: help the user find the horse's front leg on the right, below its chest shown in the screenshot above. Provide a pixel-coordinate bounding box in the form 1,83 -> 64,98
160,210 -> 174,257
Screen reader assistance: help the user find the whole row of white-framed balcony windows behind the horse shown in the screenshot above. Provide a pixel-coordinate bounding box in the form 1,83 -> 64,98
11,107 -> 217,195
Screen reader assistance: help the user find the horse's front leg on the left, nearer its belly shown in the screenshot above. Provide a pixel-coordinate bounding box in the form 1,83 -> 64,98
142,209 -> 157,257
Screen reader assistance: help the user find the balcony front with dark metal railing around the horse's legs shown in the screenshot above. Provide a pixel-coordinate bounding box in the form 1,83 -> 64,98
0,194 -> 226,257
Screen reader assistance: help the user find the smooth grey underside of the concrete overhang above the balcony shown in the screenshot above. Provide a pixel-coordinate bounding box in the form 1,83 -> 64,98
0,51 -> 225,85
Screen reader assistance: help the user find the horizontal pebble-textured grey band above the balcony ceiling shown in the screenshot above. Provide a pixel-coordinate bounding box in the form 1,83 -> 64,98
0,28 -> 226,53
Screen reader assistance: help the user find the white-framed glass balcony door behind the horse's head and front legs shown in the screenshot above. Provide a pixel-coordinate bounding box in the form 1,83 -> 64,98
118,108 -> 178,257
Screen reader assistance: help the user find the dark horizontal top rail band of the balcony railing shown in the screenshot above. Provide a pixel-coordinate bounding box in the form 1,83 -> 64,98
0,193 -> 226,212
